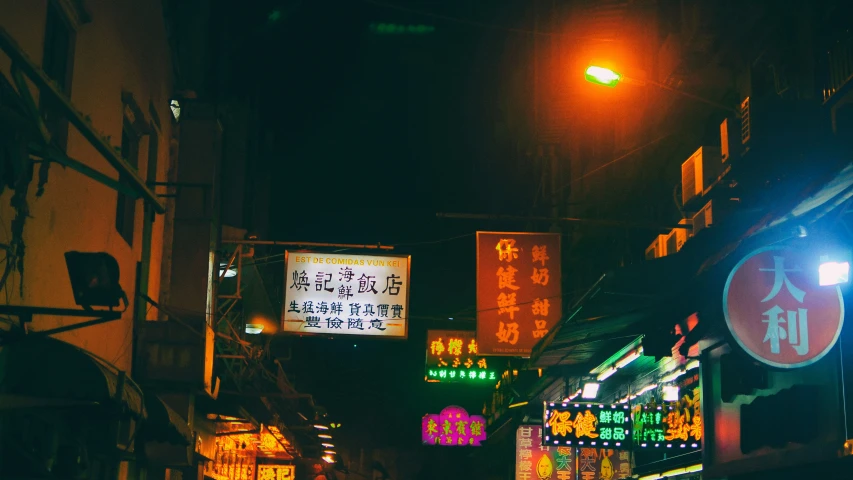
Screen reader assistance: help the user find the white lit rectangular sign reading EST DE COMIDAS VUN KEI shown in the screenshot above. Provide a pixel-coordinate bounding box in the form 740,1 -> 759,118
282,252 -> 411,338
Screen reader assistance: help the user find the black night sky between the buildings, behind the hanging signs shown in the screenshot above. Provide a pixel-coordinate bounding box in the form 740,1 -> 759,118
231,0 -> 533,458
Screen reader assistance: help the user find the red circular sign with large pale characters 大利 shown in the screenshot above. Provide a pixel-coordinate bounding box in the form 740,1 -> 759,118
723,247 -> 844,368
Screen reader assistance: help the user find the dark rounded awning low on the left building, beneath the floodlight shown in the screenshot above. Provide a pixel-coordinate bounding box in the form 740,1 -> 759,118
0,337 -> 146,419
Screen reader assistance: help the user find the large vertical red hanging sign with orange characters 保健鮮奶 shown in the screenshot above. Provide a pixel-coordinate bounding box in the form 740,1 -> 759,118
477,232 -> 562,356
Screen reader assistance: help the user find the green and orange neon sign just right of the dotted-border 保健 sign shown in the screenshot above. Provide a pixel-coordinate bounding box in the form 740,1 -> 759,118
634,388 -> 703,450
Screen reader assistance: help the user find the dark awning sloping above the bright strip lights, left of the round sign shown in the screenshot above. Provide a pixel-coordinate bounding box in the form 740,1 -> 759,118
530,255 -> 692,367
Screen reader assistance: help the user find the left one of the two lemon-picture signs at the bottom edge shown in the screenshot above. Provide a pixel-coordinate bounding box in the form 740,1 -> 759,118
515,425 -> 575,480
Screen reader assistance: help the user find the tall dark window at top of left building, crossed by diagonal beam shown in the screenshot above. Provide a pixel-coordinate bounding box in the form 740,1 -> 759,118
40,1 -> 75,151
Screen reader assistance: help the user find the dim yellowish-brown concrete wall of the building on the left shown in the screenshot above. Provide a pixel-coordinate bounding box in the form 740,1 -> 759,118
0,0 -> 172,371
